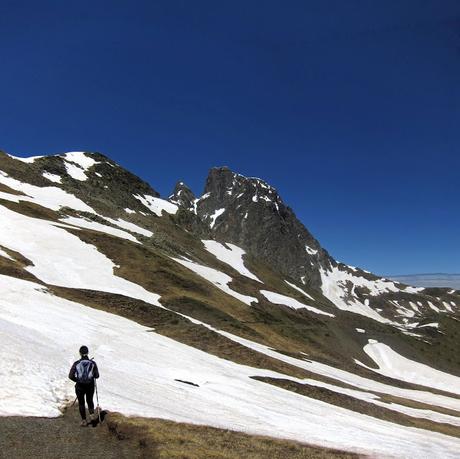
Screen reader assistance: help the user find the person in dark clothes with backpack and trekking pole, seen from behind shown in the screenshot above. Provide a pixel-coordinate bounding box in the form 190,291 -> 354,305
69,346 -> 99,426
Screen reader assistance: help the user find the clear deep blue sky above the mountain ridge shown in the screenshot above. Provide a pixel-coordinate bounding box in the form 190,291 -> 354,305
0,0 -> 460,274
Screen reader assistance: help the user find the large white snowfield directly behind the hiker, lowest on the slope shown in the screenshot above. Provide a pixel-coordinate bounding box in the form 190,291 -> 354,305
0,275 -> 460,458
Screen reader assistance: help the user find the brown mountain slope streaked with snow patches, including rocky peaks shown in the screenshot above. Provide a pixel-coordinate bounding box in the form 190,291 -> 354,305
0,152 -> 460,458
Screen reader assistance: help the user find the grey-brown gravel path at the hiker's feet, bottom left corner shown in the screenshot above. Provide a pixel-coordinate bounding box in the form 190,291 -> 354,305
0,408 -> 142,459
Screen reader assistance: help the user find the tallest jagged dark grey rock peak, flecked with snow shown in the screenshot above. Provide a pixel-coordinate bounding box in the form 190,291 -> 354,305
196,167 -> 335,288
